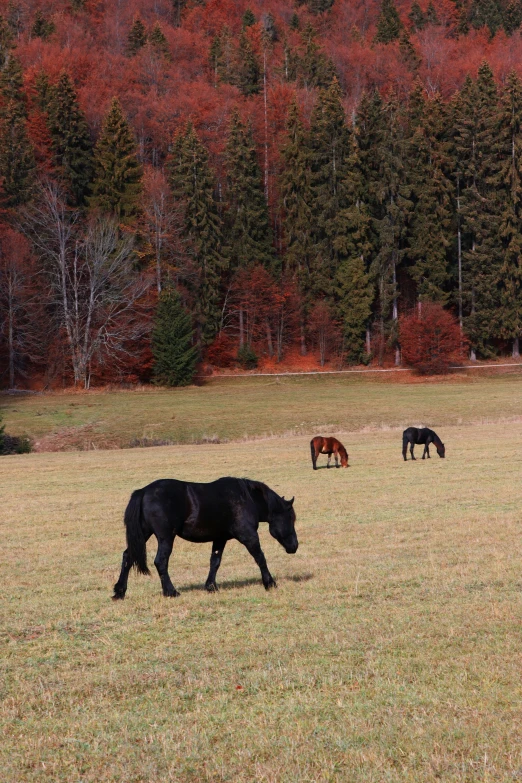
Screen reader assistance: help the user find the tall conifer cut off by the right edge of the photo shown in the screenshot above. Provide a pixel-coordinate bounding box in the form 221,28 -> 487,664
495,71 -> 522,358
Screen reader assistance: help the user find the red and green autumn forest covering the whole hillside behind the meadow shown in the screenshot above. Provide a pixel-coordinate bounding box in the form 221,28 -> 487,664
0,0 -> 522,388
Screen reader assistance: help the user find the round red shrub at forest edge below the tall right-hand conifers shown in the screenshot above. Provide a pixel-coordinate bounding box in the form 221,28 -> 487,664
399,302 -> 468,375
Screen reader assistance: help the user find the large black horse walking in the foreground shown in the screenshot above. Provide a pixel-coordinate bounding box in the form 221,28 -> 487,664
113,477 -> 298,600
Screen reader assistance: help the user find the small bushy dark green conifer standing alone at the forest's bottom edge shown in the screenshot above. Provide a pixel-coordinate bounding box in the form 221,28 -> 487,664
152,287 -> 198,386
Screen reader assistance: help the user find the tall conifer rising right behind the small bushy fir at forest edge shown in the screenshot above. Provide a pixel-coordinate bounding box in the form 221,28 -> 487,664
169,124 -> 223,345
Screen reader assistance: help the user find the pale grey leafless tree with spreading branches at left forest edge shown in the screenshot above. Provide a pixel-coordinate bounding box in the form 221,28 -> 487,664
22,182 -> 150,388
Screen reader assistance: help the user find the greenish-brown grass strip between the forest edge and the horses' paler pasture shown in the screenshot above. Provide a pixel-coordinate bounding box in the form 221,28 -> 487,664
0,372 -> 521,451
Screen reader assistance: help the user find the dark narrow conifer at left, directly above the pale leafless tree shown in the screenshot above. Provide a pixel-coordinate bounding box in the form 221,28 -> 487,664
48,72 -> 93,204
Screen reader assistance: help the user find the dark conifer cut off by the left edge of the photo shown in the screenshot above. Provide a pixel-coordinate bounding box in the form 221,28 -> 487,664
0,100 -> 36,207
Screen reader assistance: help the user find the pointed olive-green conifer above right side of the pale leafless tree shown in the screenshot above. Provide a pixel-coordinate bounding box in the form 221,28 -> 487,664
88,98 -> 141,222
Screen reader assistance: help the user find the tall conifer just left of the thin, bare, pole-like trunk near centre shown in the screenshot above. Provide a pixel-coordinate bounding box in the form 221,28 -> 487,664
226,109 -> 275,269
